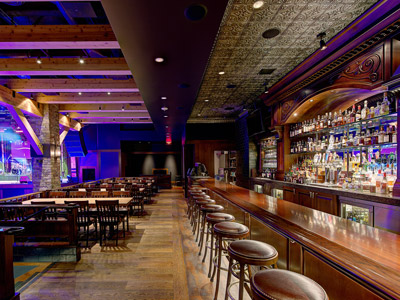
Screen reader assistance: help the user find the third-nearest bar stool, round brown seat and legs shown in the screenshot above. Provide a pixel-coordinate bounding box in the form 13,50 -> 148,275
210,222 -> 250,300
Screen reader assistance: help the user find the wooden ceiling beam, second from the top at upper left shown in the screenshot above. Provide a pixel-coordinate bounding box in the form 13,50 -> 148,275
0,57 -> 131,76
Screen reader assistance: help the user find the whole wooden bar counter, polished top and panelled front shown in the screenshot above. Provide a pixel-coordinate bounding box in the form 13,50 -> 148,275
198,179 -> 400,299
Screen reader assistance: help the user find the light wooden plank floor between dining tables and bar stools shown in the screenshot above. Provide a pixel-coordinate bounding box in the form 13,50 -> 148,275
21,188 -> 247,300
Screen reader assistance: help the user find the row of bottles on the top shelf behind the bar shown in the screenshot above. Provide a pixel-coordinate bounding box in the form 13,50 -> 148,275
290,93 -> 396,137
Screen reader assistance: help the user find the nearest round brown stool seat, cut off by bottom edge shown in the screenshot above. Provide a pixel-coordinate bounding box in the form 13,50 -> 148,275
251,269 -> 328,300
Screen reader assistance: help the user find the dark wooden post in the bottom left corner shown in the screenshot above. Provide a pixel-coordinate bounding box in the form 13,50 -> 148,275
0,231 -> 19,300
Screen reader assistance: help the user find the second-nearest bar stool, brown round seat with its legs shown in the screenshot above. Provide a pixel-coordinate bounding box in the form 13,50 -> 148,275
225,240 -> 278,300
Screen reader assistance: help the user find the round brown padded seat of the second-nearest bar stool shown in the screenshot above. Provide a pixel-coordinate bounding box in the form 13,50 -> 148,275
228,240 -> 278,266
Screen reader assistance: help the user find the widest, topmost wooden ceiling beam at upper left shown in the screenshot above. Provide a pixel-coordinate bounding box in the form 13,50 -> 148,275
0,24 -> 120,50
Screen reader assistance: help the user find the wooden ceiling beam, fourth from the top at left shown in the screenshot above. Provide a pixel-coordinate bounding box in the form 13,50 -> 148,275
35,93 -> 144,104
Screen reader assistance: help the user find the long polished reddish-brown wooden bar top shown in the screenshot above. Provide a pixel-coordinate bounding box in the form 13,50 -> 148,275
199,179 -> 400,299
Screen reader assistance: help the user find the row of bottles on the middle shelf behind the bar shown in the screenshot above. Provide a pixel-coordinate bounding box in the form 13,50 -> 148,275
290,125 -> 397,154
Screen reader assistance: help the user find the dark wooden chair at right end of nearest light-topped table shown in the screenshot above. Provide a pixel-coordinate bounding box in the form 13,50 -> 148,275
96,200 -> 125,246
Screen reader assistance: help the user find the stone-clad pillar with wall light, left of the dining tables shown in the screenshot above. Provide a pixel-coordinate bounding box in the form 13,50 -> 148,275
31,104 -> 61,192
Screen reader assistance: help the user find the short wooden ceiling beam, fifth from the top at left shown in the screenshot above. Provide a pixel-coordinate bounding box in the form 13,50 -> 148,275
59,103 -> 147,113
